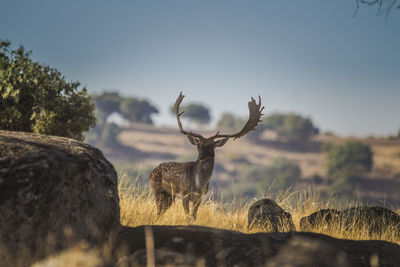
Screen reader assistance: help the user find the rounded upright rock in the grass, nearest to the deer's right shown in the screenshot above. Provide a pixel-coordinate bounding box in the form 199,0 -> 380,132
247,198 -> 296,232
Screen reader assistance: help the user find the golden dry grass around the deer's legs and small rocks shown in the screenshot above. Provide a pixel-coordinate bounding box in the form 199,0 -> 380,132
119,177 -> 400,244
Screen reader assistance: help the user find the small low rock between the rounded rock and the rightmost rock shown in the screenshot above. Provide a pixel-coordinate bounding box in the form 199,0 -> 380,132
300,209 -> 341,231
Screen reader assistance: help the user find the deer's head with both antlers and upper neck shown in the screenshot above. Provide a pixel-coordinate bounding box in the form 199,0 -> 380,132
174,92 -> 264,161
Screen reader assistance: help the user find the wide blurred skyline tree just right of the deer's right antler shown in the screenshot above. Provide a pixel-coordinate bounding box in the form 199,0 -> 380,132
262,113 -> 318,143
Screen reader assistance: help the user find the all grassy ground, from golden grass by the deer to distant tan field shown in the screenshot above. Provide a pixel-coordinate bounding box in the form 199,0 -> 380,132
111,125 -> 400,244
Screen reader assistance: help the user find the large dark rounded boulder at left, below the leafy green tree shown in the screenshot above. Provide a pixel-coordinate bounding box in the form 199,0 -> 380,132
0,131 -> 119,266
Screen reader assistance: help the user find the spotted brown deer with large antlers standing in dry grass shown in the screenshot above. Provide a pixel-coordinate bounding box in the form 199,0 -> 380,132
149,92 -> 264,221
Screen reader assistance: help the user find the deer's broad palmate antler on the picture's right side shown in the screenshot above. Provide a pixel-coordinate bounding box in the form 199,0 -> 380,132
212,96 -> 265,139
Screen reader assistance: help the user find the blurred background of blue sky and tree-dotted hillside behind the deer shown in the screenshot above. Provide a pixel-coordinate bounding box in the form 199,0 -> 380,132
0,0 -> 400,206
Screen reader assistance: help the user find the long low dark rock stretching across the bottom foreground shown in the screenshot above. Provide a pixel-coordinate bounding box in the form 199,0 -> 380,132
110,226 -> 400,267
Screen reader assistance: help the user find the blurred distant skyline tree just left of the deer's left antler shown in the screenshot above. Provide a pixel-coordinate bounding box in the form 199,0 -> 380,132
120,98 -> 158,124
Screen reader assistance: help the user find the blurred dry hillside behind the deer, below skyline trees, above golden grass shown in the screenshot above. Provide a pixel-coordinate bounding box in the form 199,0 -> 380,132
103,124 -> 400,205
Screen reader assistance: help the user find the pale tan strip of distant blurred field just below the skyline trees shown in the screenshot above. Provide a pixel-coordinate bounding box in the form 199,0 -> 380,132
118,124 -> 400,179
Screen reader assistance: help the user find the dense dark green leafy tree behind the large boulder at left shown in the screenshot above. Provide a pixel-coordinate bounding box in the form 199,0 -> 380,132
0,41 -> 96,140
